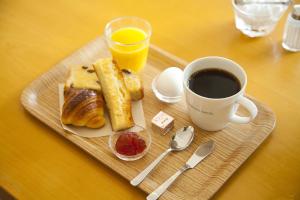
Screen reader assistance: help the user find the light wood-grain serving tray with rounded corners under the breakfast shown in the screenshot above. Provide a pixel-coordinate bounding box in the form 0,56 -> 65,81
21,37 -> 275,199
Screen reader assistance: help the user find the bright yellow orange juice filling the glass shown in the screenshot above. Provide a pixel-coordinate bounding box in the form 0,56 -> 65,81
109,27 -> 149,72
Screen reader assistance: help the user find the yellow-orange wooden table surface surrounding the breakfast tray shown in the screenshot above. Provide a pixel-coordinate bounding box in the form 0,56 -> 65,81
0,0 -> 300,200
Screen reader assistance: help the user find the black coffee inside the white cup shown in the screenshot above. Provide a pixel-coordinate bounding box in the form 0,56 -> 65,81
188,68 -> 241,99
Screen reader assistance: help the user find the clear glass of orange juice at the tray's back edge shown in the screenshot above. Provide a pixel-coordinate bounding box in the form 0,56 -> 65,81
105,17 -> 151,73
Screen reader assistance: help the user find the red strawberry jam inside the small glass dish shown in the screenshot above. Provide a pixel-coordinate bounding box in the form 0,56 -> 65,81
116,132 -> 146,156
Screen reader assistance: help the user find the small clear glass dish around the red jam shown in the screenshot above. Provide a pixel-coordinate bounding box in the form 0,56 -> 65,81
108,131 -> 152,161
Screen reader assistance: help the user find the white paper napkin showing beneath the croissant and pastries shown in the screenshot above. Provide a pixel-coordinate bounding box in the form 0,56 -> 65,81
58,84 -> 146,138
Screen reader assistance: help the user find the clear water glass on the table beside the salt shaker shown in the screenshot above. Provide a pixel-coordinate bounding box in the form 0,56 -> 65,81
232,0 -> 290,37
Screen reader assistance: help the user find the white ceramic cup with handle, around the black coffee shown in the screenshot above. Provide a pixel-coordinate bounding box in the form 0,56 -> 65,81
183,56 -> 257,131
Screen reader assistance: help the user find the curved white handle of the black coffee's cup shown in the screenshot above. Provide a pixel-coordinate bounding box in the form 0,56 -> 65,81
229,96 -> 257,124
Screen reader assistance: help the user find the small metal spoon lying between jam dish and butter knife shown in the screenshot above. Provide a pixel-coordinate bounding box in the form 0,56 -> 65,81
130,126 -> 194,186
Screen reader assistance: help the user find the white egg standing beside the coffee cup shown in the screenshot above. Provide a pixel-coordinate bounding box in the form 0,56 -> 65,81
156,67 -> 183,97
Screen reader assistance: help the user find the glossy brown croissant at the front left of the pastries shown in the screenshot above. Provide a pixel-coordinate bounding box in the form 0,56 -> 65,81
61,87 -> 105,128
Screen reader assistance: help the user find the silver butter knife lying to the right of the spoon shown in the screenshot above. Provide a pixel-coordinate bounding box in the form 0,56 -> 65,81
147,140 -> 215,200
